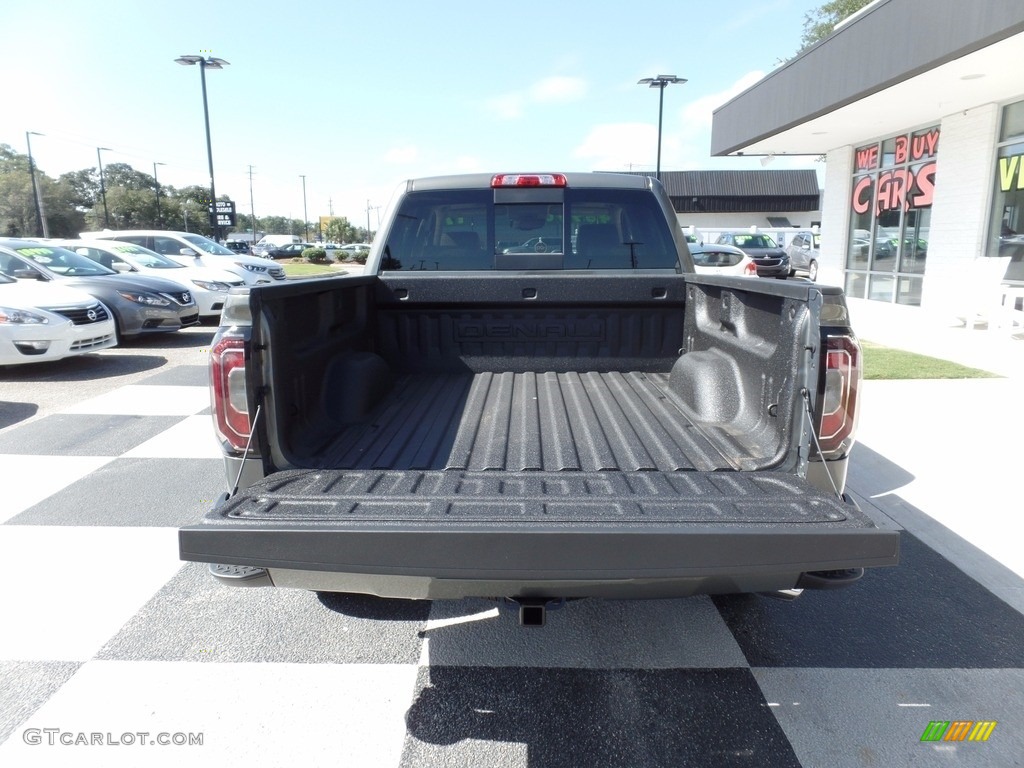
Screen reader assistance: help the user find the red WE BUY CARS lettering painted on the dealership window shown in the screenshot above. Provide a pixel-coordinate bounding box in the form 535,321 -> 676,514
851,128 -> 939,215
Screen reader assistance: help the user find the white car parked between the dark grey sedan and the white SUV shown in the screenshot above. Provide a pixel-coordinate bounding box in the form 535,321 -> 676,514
53,240 -> 244,317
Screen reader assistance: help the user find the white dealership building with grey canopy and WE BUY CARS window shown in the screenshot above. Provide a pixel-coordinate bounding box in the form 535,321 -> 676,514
712,0 -> 1024,309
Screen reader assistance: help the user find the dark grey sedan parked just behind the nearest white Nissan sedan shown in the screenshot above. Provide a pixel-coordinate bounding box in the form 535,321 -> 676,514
0,238 -> 199,338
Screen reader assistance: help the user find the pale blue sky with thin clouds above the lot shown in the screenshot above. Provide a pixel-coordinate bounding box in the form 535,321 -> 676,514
0,0 -> 820,228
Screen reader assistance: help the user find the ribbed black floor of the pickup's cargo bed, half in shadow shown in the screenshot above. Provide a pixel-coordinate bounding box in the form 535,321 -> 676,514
316,372 -> 735,472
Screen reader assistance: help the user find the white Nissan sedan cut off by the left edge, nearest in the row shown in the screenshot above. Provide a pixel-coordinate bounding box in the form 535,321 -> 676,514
0,272 -> 117,366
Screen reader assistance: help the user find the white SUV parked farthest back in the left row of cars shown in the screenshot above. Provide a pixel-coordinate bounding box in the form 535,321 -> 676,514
79,229 -> 285,286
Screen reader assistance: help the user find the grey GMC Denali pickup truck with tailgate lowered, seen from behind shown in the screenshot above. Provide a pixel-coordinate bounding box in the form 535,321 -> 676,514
179,173 -> 899,625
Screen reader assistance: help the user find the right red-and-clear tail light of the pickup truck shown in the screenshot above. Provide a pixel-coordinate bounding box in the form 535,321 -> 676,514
818,336 -> 862,459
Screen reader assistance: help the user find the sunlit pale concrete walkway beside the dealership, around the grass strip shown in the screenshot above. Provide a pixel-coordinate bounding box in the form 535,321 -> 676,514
848,299 -> 1024,612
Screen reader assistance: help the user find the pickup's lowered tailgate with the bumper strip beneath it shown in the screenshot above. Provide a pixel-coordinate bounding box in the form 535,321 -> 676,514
179,473 -> 899,599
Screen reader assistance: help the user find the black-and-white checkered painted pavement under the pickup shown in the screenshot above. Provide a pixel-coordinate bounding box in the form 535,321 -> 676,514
0,366 -> 1024,767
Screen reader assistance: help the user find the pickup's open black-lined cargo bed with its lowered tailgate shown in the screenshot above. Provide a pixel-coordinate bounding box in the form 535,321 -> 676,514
179,272 -> 898,599
